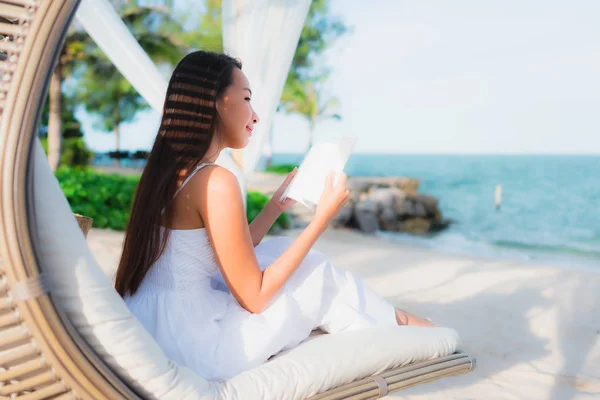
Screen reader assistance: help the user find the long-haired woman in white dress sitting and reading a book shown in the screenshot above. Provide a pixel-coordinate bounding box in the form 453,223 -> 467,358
115,51 -> 430,380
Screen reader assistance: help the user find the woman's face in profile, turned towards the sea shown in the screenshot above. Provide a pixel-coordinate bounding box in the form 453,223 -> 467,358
217,68 -> 258,149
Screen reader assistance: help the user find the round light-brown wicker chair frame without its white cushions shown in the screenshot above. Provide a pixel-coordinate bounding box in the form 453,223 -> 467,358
0,0 -> 474,400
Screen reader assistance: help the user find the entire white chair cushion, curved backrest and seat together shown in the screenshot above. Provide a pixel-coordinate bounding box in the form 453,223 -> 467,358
32,140 -> 458,400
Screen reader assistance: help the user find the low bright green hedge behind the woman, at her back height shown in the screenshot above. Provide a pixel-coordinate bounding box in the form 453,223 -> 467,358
56,166 -> 290,231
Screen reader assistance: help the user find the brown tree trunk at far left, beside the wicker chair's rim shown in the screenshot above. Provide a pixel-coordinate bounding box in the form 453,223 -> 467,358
48,64 -> 62,171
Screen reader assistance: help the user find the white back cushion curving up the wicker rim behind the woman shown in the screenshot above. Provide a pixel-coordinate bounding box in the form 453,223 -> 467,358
32,140 -> 219,399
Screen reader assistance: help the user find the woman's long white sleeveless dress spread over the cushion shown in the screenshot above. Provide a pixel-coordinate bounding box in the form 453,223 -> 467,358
125,165 -> 397,380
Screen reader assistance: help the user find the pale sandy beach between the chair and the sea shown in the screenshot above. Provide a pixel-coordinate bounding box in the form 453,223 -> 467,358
88,225 -> 600,400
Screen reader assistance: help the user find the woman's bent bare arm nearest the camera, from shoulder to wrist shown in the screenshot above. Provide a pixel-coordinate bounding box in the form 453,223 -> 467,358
194,166 -> 328,313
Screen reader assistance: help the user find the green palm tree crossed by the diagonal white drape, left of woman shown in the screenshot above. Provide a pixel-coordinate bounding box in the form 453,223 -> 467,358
77,1 -> 186,165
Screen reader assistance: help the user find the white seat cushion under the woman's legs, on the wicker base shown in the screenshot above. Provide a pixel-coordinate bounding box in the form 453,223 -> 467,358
219,326 -> 458,399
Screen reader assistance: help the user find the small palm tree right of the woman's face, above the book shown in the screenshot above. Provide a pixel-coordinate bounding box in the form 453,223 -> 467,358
281,80 -> 341,150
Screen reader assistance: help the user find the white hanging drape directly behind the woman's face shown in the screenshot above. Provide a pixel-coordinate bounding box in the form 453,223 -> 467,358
222,0 -> 311,175
